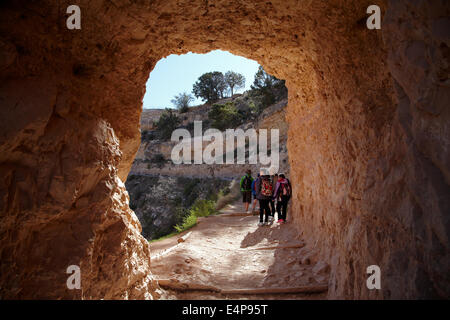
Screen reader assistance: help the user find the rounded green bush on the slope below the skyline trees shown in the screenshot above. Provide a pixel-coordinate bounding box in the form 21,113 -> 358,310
208,102 -> 242,130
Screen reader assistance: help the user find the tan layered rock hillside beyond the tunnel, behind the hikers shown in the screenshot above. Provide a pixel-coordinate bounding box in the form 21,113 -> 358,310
130,99 -> 289,180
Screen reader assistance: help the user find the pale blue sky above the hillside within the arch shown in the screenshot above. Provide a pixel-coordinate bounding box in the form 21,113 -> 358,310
143,50 -> 259,109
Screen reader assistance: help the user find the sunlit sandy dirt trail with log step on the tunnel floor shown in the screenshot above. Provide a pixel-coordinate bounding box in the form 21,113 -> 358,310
150,203 -> 328,299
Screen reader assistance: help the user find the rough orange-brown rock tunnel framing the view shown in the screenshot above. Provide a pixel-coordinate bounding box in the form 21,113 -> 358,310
0,0 -> 450,299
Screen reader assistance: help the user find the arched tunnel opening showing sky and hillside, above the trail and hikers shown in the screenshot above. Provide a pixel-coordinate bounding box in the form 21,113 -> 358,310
125,51 -> 289,241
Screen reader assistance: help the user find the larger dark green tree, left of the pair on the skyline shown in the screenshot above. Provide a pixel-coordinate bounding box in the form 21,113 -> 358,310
192,71 -> 227,103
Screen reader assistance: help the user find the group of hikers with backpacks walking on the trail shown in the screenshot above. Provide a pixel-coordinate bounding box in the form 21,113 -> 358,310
240,168 -> 292,226
